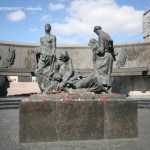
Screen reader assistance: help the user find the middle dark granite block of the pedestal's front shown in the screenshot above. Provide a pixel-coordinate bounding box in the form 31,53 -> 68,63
59,101 -> 104,141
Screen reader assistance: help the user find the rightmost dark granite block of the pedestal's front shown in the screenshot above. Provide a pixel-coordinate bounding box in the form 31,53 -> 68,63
104,100 -> 138,139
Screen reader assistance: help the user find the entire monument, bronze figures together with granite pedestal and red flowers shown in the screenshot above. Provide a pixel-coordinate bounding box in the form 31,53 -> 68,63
19,24 -> 138,142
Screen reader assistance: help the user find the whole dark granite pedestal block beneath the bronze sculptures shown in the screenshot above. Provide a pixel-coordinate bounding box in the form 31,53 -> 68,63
19,96 -> 138,143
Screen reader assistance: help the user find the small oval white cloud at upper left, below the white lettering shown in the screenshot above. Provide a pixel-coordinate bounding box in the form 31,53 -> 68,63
7,10 -> 26,22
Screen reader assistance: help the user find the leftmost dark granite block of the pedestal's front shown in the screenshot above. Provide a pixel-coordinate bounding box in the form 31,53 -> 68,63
19,102 -> 58,142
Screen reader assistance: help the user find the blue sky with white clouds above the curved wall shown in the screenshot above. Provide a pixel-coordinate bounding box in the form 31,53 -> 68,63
0,0 -> 150,45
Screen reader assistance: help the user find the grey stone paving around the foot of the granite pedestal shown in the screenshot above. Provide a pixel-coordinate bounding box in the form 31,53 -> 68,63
0,109 -> 150,150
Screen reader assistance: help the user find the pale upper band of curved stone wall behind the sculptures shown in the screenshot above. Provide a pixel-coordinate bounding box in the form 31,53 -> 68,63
0,41 -> 150,69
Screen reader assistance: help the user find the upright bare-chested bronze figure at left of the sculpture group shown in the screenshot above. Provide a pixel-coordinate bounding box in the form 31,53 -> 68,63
35,24 -> 56,92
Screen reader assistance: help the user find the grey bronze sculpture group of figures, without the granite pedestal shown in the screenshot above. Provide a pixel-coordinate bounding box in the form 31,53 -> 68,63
34,24 -> 115,94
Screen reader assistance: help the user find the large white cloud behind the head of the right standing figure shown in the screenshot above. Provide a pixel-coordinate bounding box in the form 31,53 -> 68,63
53,0 -> 143,43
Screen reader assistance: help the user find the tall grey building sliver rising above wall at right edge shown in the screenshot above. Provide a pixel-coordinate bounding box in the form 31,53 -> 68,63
143,10 -> 150,41
